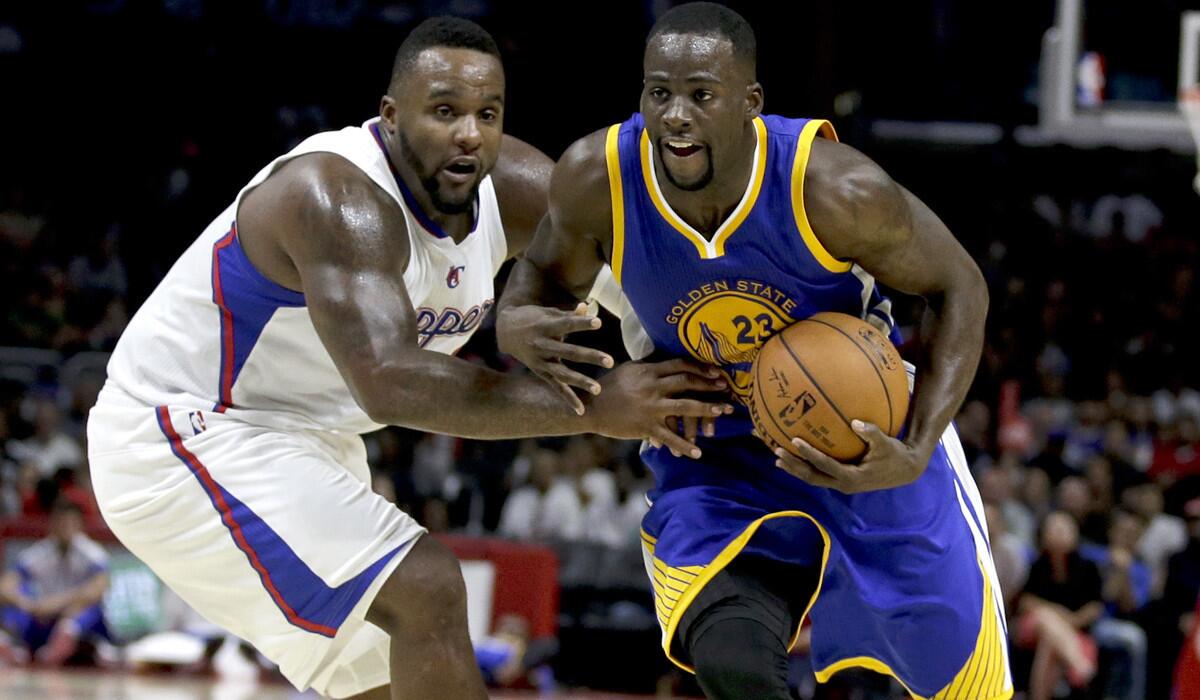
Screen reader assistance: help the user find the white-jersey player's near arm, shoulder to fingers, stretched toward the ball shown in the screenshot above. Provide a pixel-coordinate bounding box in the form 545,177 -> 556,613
239,154 -> 721,449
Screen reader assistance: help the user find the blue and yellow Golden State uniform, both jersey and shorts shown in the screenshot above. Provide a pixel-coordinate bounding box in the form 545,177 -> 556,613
606,114 -> 1012,700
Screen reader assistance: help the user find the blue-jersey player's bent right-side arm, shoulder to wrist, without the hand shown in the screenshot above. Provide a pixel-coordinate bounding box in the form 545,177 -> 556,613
804,139 -> 988,468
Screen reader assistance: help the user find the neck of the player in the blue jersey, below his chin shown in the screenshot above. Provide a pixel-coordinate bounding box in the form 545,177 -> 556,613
654,121 -> 758,238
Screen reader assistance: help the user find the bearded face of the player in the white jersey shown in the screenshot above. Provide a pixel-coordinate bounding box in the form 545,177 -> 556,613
382,48 -> 504,214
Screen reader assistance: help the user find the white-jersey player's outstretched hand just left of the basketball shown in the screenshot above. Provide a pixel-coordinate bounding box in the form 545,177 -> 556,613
586,359 -> 733,459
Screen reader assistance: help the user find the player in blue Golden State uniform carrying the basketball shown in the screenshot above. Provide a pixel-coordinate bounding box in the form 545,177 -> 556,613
498,2 -> 1012,700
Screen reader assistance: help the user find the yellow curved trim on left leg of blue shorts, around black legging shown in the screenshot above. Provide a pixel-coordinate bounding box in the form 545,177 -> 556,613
642,510 -> 829,674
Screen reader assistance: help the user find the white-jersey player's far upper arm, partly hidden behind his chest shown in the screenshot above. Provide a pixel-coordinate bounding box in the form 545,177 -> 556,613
492,136 -> 554,258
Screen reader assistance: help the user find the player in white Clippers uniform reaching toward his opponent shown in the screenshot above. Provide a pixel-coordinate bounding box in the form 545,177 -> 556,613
88,18 -> 727,700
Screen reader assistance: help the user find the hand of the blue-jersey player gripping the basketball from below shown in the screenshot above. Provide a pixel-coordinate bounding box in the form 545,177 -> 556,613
775,420 -> 930,493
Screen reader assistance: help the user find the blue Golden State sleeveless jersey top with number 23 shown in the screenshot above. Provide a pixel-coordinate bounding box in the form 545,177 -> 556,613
607,114 -> 899,413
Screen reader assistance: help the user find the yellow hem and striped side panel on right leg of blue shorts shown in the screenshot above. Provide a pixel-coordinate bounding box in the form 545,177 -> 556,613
814,562 -> 1013,700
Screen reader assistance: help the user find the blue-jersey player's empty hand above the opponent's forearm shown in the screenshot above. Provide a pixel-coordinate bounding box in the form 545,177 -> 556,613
496,304 -> 613,414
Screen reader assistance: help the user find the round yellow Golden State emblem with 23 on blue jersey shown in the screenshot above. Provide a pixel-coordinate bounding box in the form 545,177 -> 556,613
666,280 -> 797,397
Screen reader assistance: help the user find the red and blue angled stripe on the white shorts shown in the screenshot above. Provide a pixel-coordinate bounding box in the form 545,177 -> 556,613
155,406 -> 400,638
